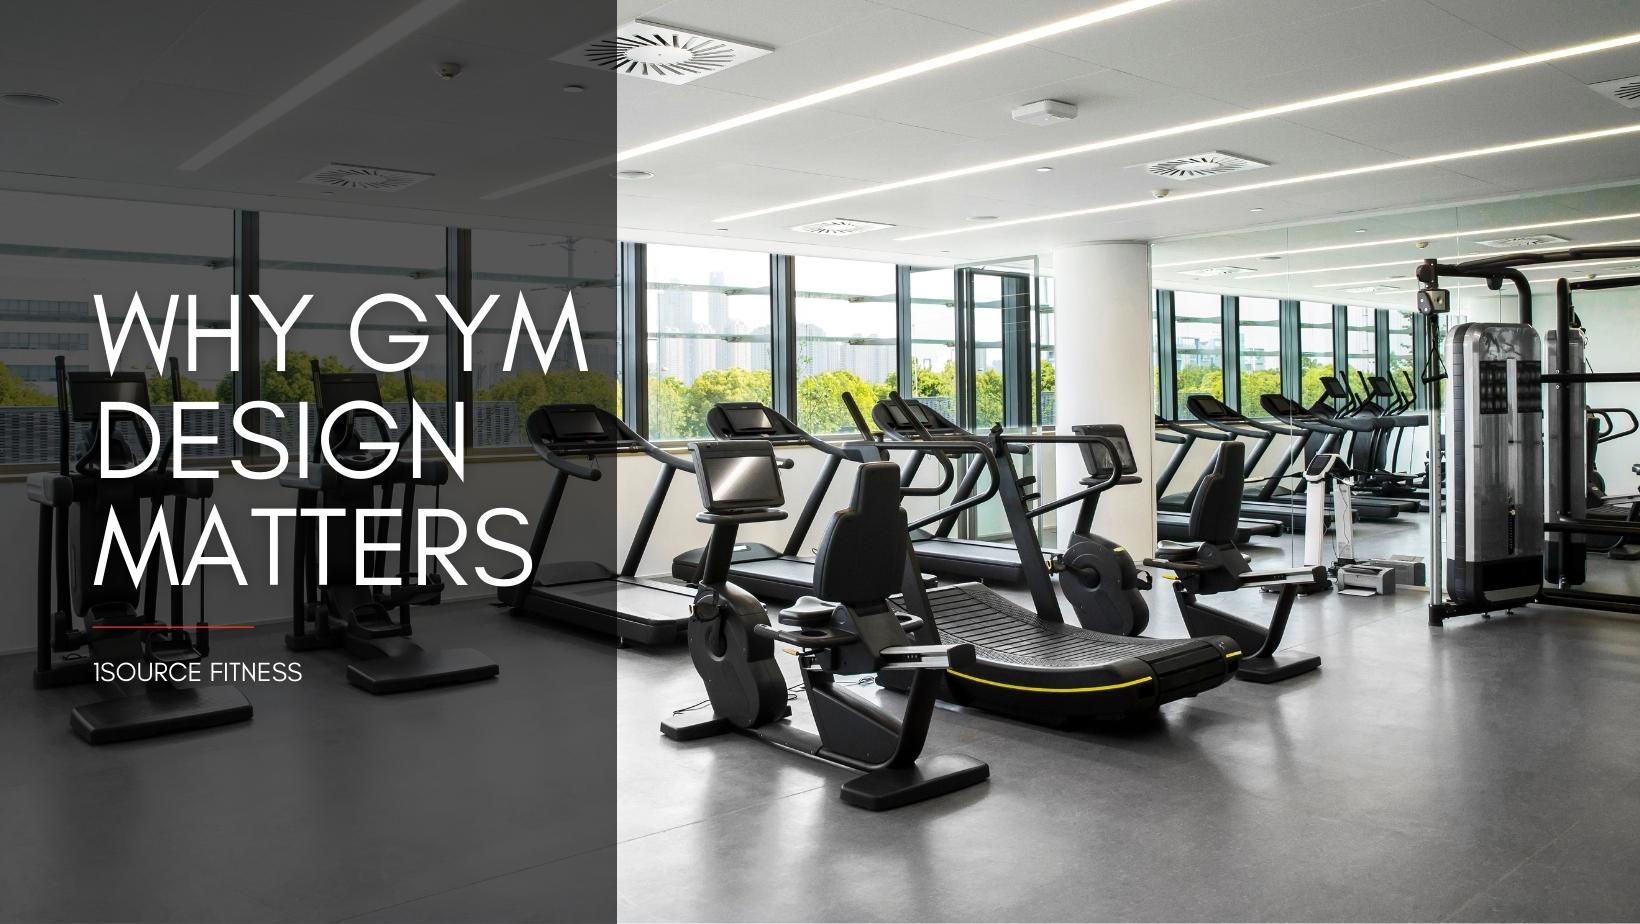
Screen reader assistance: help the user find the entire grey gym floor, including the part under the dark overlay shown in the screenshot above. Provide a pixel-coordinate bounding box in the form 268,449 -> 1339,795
0,508 -> 1640,921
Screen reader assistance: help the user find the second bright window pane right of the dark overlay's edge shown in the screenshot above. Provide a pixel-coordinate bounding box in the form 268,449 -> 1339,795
794,256 -> 899,433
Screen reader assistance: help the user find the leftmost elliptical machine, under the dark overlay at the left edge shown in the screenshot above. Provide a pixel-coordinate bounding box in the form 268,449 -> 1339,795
28,356 -> 251,745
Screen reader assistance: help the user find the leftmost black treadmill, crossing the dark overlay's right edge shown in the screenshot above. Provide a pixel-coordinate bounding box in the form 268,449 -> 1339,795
499,404 -> 695,645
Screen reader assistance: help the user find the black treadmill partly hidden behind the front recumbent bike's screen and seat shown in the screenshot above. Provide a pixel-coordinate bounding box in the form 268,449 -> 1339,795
672,400 -> 933,601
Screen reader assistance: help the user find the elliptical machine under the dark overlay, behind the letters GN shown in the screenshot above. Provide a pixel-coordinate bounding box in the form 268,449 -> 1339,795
279,359 -> 500,693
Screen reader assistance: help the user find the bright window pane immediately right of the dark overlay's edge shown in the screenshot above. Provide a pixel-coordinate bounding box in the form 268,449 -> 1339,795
645,245 -> 774,440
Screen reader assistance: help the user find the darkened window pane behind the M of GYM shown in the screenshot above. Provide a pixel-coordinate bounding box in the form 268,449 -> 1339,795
472,230 -> 620,448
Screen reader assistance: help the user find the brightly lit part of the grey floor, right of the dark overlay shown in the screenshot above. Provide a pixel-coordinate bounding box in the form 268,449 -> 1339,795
618,517 -> 1640,921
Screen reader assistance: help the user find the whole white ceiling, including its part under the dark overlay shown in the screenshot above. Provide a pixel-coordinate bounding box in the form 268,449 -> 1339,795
0,0 -> 1640,263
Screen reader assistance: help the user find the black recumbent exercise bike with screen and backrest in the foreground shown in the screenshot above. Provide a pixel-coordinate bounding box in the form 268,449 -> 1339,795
661,440 -> 991,811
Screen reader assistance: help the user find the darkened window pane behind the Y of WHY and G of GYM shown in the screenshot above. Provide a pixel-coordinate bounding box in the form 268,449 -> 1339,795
257,212 -> 451,446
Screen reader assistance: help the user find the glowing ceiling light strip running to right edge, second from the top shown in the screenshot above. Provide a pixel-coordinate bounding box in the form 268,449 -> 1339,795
713,33 -> 1640,222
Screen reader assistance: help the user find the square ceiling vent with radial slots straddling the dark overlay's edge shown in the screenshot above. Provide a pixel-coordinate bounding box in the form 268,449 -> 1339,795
553,20 -> 771,84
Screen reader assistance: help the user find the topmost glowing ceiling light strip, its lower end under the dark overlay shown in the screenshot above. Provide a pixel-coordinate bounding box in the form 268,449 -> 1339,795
484,0 -> 1173,199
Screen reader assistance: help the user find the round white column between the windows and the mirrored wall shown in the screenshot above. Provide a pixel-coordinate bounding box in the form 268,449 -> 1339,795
1053,241 -> 1156,560
